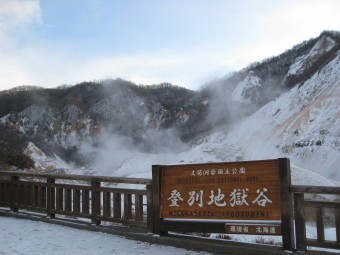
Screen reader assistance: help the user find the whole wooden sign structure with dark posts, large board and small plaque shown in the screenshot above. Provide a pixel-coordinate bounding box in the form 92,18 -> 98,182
152,159 -> 294,250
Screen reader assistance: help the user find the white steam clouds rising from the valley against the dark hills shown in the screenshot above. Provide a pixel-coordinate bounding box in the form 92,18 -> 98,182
81,74 -> 290,176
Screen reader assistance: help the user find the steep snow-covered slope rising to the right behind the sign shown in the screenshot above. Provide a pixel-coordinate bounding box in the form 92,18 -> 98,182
189,47 -> 340,180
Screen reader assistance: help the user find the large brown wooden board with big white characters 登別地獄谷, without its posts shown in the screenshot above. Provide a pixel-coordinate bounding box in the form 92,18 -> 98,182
160,160 -> 281,221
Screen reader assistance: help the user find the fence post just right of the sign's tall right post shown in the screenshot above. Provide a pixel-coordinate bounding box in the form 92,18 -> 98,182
294,193 -> 306,252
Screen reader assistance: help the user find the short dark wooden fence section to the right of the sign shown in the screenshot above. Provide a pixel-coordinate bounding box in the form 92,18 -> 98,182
290,186 -> 340,251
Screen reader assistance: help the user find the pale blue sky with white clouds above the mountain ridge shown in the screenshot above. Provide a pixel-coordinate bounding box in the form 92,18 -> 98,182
0,0 -> 340,90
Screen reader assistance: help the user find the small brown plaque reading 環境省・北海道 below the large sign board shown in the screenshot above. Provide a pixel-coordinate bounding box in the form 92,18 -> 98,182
225,223 -> 281,236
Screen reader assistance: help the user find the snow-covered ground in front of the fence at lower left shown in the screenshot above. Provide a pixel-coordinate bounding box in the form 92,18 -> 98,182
0,217 -> 209,255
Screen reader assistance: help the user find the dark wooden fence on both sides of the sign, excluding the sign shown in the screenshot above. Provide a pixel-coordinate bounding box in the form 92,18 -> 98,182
0,171 -> 340,252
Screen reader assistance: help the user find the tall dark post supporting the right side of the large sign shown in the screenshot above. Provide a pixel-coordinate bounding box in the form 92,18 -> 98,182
279,158 -> 295,251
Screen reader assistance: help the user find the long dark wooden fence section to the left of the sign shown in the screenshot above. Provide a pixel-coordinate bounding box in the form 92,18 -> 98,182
0,171 -> 151,228
